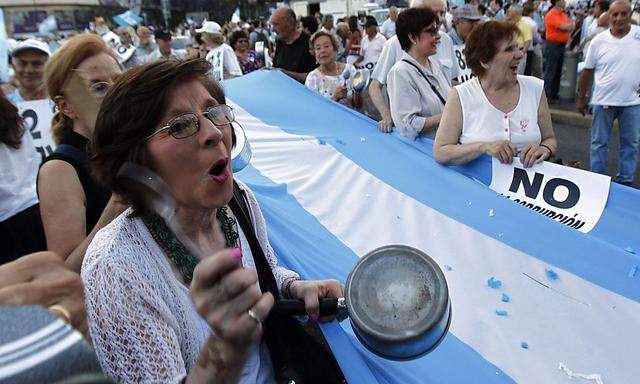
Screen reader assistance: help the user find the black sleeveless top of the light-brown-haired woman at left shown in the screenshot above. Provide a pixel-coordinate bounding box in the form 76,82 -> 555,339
42,131 -> 111,234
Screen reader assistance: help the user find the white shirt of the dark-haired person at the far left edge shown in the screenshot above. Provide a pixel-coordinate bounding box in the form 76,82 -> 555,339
0,130 -> 40,221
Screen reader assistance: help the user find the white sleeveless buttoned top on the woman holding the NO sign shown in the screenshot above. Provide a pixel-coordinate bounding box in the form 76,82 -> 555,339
456,75 -> 544,151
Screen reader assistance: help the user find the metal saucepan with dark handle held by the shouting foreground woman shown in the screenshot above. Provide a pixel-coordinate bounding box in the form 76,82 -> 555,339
272,245 -> 451,360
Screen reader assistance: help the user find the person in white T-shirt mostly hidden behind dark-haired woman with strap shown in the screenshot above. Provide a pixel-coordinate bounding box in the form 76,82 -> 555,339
369,0 -> 459,132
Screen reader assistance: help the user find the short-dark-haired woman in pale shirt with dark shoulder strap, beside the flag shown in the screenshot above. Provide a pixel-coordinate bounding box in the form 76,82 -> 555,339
387,8 -> 451,140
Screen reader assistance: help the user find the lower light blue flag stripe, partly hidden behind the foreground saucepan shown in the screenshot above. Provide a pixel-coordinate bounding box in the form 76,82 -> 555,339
236,166 -> 517,384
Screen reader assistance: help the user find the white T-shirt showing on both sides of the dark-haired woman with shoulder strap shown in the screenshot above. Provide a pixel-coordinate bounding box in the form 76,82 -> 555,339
371,32 -> 460,84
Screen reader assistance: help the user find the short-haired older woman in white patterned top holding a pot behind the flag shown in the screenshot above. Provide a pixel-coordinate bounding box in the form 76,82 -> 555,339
304,30 -> 362,108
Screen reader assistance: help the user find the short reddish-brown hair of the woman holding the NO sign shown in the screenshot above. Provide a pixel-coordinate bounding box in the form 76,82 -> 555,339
464,21 -> 520,77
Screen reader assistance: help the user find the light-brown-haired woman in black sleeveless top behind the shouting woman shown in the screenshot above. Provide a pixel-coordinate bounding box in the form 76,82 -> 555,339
37,34 -> 129,271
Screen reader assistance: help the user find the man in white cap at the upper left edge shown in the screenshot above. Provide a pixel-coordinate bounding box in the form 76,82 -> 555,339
8,39 -> 51,104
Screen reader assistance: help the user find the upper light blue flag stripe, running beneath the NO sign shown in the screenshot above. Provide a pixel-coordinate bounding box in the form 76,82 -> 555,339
225,71 -> 640,301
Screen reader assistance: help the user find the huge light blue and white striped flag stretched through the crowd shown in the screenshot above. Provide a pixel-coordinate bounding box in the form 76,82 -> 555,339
224,71 -> 640,384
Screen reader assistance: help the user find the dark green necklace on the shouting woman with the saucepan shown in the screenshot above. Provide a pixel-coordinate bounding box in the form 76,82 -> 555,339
142,206 -> 239,285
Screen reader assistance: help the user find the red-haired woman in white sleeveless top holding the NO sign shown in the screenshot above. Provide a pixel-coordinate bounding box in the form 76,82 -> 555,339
433,21 -> 556,167
